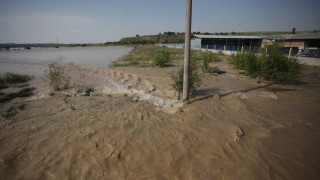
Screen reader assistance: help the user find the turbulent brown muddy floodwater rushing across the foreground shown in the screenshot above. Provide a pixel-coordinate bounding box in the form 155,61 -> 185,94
0,62 -> 320,180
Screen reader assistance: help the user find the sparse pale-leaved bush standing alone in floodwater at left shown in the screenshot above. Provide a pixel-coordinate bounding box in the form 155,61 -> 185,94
44,63 -> 71,91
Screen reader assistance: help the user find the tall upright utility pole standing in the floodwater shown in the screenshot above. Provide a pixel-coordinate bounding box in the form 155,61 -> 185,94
182,0 -> 192,102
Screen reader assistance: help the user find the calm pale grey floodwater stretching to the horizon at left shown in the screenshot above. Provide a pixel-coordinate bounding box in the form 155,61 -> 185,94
0,47 -> 132,76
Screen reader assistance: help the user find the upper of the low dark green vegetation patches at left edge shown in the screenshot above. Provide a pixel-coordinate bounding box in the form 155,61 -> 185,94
0,72 -> 31,88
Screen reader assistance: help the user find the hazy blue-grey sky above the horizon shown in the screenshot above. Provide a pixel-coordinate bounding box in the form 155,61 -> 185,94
0,0 -> 320,43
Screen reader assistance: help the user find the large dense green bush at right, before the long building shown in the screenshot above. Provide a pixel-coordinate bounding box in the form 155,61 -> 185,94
231,42 -> 301,80
